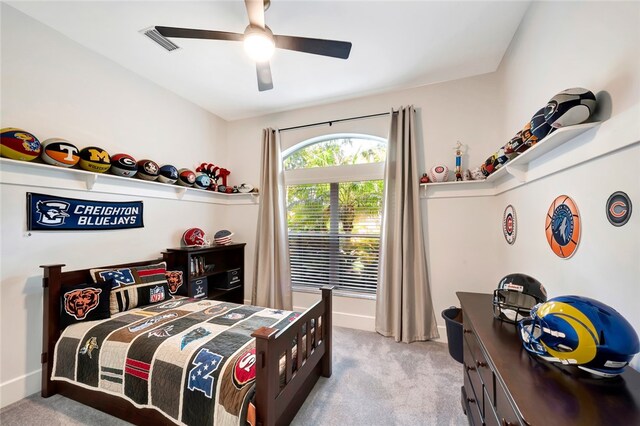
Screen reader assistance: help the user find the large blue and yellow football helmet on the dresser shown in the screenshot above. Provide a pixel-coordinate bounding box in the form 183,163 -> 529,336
518,296 -> 640,377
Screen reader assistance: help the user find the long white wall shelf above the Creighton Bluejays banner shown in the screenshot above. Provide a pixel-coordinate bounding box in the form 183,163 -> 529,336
0,158 -> 259,204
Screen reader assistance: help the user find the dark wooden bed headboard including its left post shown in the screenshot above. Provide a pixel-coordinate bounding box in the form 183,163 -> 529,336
40,259 -> 163,398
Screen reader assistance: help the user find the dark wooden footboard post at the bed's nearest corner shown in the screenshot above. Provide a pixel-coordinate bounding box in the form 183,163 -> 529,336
251,327 -> 279,426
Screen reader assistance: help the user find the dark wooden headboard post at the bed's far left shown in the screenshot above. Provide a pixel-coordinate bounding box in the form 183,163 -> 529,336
40,264 -> 65,398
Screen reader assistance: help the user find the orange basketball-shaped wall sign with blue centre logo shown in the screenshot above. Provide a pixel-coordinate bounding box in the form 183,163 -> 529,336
544,195 -> 580,259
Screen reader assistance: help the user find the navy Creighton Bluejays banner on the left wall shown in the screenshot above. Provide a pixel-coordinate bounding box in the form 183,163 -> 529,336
27,192 -> 144,231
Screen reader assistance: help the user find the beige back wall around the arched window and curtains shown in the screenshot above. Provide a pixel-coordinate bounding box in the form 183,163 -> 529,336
227,74 -> 508,337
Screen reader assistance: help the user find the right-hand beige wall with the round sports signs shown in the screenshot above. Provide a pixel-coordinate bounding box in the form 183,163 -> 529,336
493,2 -> 640,369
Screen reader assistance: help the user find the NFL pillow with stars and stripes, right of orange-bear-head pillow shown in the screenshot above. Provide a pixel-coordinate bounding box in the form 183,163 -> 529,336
89,262 -> 171,314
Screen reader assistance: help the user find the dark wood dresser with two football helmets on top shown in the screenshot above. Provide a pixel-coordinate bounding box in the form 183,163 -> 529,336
457,292 -> 640,426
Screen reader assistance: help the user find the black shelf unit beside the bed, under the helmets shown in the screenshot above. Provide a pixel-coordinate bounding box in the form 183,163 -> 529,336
163,243 -> 246,303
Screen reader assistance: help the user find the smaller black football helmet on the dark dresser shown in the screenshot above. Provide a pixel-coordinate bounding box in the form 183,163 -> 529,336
493,274 -> 547,324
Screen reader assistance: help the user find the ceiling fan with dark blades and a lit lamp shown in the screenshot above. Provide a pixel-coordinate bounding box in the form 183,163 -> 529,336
155,0 -> 351,92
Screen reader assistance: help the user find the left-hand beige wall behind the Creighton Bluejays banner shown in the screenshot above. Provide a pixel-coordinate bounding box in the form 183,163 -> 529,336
0,4 -> 226,406
